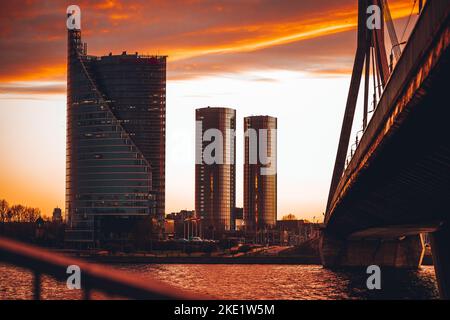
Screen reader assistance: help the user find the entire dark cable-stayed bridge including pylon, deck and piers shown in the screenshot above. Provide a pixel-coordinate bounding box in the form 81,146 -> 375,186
321,0 -> 450,298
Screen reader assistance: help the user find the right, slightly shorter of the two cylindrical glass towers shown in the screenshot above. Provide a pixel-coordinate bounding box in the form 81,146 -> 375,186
244,116 -> 277,231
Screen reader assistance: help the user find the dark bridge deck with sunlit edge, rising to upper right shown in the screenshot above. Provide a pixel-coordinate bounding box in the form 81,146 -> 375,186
325,0 -> 450,236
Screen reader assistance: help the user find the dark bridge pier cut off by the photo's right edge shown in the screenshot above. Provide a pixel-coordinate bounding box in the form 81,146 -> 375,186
431,223 -> 450,299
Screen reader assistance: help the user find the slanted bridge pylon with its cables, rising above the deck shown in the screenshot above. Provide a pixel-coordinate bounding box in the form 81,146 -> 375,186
325,0 -> 401,216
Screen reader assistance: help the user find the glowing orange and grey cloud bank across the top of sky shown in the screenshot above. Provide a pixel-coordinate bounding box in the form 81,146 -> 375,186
0,0 -> 411,86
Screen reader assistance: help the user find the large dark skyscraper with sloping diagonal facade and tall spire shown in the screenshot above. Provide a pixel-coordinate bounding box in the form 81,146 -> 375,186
66,24 -> 166,246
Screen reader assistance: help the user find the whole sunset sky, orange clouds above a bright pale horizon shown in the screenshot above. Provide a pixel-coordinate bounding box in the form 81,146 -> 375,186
0,0 -> 417,219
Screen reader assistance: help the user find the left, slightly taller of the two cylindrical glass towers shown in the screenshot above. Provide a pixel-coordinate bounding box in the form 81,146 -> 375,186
195,107 -> 236,238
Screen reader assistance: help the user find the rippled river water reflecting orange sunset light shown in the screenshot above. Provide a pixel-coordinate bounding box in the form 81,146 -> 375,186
0,264 -> 438,299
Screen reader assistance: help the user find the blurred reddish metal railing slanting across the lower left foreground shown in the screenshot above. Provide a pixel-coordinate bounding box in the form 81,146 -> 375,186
0,237 -> 200,300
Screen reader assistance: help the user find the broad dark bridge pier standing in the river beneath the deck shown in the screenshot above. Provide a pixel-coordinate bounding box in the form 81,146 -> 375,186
320,234 -> 425,269
